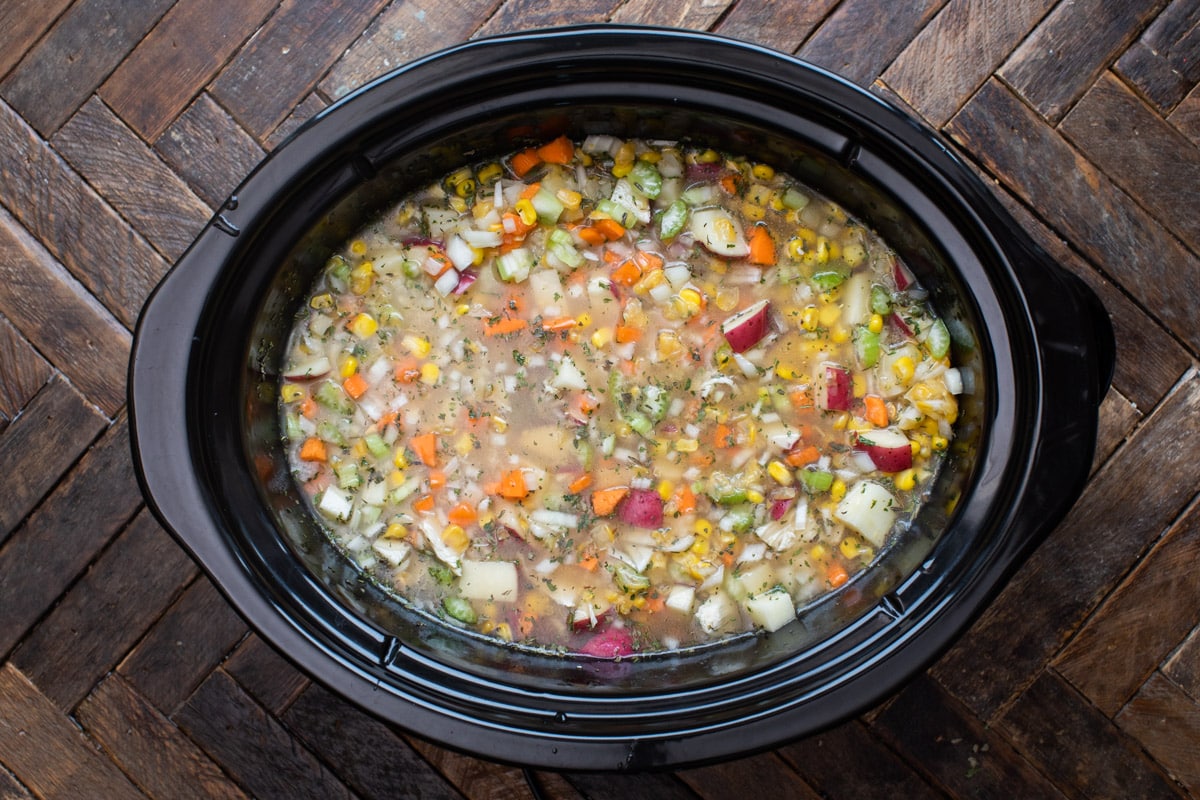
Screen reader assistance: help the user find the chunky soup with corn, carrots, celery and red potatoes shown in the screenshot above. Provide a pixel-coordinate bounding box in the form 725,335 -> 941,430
281,136 -> 962,657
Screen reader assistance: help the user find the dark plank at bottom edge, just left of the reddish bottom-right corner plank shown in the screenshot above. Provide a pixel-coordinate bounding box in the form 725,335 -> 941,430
996,672 -> 1180,800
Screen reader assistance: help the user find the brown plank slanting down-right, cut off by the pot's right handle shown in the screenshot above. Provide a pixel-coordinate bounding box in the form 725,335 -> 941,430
997,178 -> 1192,413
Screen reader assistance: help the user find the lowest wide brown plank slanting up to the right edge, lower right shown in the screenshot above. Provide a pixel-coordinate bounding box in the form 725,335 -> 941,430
1055,494 -> 1200,716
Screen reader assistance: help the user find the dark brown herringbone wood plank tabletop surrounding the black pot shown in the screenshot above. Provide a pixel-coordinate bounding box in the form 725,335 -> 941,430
0,0 -> 1200,800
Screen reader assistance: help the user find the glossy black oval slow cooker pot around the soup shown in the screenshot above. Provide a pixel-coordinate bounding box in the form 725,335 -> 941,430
130,26 -> 1114,769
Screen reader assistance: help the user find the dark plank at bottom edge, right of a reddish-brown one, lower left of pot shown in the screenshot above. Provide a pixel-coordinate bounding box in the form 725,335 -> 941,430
175,670 -> 354,800
